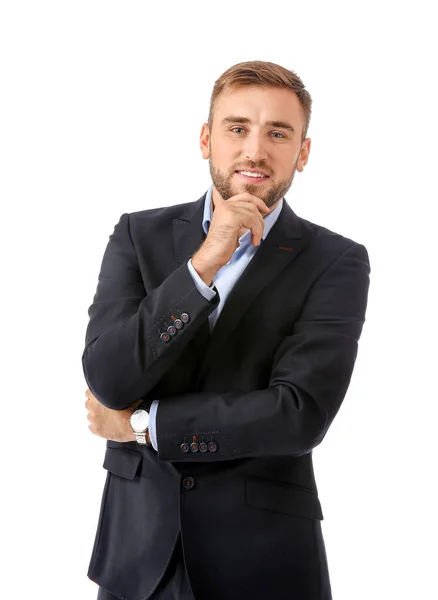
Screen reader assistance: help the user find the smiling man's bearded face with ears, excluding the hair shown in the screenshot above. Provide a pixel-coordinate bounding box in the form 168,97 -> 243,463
201,86 -> 310,207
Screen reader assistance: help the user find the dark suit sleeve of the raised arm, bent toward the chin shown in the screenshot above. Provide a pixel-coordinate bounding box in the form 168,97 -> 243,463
82,213 -> 219,410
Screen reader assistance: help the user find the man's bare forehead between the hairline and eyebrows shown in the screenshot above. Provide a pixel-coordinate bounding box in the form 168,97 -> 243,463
214,85 -> 304,126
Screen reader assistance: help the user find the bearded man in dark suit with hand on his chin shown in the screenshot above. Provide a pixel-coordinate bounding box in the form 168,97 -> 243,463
83,61 -> 370,600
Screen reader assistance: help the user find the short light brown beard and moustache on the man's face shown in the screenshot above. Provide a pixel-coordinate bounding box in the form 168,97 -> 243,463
209,150 -> 298,208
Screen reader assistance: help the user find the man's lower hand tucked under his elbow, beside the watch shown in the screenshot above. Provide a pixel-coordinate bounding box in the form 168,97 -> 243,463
85,389 -> 142,442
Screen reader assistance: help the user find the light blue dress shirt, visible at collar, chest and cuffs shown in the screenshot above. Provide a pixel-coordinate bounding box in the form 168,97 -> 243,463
149,185 -> 283,451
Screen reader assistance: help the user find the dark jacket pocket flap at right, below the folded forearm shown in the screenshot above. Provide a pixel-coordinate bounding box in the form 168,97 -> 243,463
245,478 -> 324,520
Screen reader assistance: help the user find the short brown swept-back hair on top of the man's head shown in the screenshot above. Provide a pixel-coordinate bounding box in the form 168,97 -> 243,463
208,60 -> 312,140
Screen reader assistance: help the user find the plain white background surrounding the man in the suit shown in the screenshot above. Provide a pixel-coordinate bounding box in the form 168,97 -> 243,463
0,0 -> 438,600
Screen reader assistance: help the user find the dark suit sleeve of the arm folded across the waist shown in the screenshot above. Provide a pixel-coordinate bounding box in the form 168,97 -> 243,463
156,243 -> 370,462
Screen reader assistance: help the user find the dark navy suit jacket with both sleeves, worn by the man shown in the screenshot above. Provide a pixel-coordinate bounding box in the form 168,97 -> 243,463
82,195 -> 370,600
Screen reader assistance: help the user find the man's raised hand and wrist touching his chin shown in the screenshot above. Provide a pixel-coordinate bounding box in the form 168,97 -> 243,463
192,192 -> 270,285
